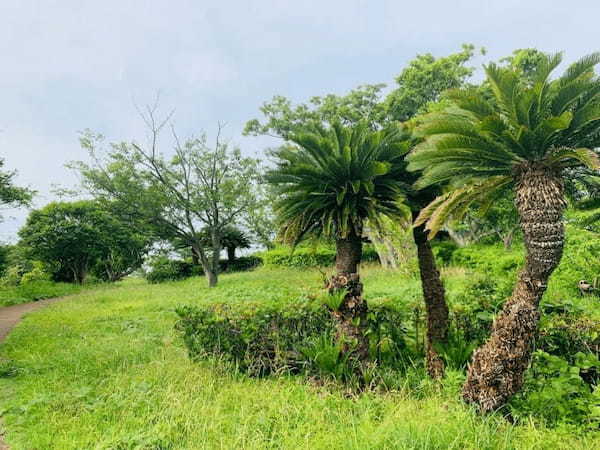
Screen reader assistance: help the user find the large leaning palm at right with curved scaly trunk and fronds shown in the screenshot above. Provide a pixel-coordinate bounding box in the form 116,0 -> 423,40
409,53 -> 600,411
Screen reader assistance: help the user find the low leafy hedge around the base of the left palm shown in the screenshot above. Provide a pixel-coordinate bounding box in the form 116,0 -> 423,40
176,298 -> 408,378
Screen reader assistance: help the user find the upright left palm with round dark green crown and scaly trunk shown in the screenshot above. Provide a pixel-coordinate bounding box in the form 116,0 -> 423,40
267,123 -> 409,360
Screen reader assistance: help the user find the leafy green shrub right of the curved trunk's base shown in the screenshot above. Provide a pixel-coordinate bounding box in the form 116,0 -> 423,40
511,351 -> 600,430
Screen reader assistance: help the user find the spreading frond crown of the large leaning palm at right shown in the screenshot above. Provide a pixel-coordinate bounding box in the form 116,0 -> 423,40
408,53 -> 600,235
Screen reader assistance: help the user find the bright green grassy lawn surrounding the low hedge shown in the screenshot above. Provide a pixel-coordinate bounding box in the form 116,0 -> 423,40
0,268 -> 600,450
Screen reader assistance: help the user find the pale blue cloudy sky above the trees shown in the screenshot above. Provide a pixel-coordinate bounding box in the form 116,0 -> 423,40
0,0 -> 600,242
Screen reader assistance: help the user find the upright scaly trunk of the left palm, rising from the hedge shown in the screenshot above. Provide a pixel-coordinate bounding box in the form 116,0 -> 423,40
327,232 -> 369,361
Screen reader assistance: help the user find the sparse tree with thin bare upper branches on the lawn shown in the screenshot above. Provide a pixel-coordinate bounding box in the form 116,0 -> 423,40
72,105 -> 259,287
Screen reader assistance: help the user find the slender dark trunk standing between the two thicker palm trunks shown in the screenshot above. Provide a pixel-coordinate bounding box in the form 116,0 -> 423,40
413,211 -> 448,379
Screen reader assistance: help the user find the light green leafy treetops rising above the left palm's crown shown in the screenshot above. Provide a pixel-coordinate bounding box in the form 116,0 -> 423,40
244,45 -> 475,140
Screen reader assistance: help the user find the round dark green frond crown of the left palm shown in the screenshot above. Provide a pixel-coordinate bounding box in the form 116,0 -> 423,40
267,123 -> 409,243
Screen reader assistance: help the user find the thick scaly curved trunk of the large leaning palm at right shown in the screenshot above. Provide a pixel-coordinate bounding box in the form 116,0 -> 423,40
463,164 -> 566,412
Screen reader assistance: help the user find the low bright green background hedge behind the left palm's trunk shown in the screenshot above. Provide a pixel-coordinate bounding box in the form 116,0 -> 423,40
257,246 -> 379,267
